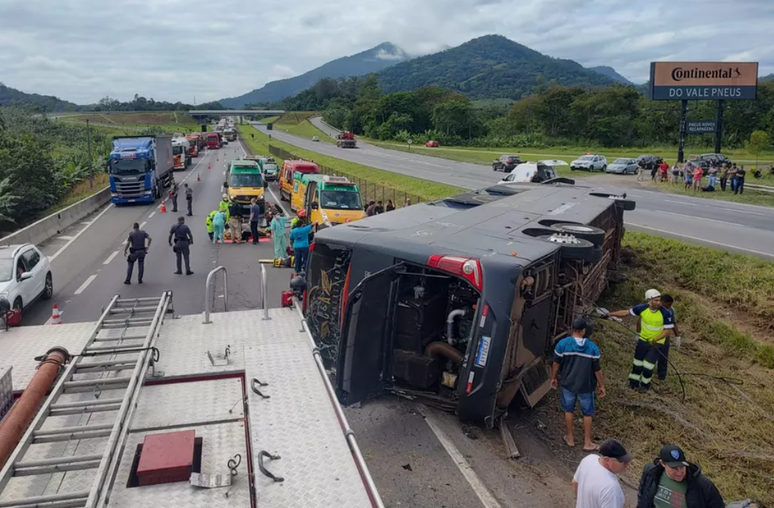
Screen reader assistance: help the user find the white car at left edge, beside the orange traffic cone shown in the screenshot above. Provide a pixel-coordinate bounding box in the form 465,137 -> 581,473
0,243 -> 54,322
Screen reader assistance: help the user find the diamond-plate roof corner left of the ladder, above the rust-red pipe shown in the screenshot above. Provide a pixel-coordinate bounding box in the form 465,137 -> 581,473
0,323 -> 94,391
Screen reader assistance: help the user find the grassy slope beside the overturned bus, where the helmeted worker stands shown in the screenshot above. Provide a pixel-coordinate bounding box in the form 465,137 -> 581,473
539,232 -> 774,504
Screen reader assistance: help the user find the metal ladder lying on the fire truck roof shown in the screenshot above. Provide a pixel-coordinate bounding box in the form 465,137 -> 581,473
0,291 -> 174,508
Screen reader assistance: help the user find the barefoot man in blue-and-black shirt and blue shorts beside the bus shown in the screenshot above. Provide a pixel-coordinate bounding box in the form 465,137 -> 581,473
551,318 -> 605,452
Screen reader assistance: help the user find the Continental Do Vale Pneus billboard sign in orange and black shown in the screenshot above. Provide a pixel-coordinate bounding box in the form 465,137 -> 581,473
650,62 -> 758,101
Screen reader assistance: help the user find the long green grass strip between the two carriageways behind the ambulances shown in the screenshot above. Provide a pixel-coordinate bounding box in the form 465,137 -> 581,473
237,125 -> 464,203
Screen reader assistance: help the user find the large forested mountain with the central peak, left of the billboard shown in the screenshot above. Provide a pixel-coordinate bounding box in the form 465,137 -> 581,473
378,35 -> 615,99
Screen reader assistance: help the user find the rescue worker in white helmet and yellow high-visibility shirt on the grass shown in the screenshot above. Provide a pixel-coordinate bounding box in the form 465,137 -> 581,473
608,289 -> 675,393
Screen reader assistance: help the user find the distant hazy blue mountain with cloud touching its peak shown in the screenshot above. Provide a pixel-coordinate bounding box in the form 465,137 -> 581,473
220,42 -> 408,108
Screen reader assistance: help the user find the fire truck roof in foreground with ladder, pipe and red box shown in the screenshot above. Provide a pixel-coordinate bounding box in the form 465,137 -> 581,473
0,274 -> 384,508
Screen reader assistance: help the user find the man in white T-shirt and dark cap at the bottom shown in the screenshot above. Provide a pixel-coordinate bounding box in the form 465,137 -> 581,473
572,439 -> 632,508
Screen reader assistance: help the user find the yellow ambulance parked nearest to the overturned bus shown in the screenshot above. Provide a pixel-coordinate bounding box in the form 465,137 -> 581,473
290,172 -> 365,226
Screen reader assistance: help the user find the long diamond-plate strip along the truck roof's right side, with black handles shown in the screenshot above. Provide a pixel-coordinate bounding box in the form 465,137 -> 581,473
245,309 -> 371,508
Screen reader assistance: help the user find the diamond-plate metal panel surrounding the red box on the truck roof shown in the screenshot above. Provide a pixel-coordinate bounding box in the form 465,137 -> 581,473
108,422 -> 249,508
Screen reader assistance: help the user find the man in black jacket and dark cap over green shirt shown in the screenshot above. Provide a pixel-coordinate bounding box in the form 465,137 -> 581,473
637,445 -> 726,508
